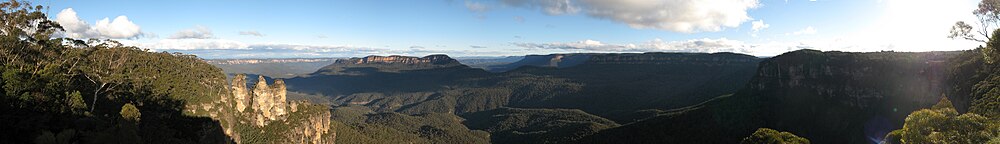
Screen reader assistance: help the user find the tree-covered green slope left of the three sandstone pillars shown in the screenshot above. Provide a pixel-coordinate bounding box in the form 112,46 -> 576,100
0,1 -> 228,143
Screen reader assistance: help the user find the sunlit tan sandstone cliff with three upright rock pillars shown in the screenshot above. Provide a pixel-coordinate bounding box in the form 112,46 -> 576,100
213,74 -> 336,144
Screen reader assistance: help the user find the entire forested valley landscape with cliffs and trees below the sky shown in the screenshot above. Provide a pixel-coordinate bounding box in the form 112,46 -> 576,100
0,1 -> 1000,144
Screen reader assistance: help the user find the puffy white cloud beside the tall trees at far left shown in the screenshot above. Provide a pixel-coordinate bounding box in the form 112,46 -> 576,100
56,8 -> 143,39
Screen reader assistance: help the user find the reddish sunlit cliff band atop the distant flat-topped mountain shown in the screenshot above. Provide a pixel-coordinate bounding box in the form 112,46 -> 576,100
335,55 -> 458,64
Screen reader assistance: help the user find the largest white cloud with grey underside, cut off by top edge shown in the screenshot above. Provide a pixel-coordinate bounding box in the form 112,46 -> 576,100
501,0 -> 760,33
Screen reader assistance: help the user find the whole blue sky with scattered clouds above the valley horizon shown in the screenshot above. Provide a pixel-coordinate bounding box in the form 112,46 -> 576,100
41,0 -> 982,59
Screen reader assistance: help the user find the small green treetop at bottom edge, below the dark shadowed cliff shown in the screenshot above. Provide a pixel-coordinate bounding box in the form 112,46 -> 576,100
740,128 -> 809,144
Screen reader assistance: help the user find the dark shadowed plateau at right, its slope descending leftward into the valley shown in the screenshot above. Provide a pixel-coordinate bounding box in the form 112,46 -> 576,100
585,50 -> 967,143
